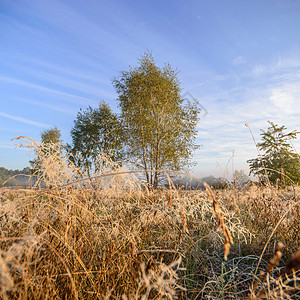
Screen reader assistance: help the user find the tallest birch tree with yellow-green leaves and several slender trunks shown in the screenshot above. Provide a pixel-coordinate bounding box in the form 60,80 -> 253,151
113,53 -> 199,188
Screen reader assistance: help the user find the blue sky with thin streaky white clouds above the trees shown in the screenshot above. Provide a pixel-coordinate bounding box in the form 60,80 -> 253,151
0,0 -> 300,176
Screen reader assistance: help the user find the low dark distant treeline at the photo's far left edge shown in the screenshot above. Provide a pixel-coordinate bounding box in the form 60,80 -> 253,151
0,167 -> 30,187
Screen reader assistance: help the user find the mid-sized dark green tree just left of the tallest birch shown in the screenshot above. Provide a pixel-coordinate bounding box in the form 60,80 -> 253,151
70,102 -> 123,177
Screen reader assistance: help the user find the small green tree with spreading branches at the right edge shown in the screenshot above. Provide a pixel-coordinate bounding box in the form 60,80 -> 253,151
247,122 -> 300,184
